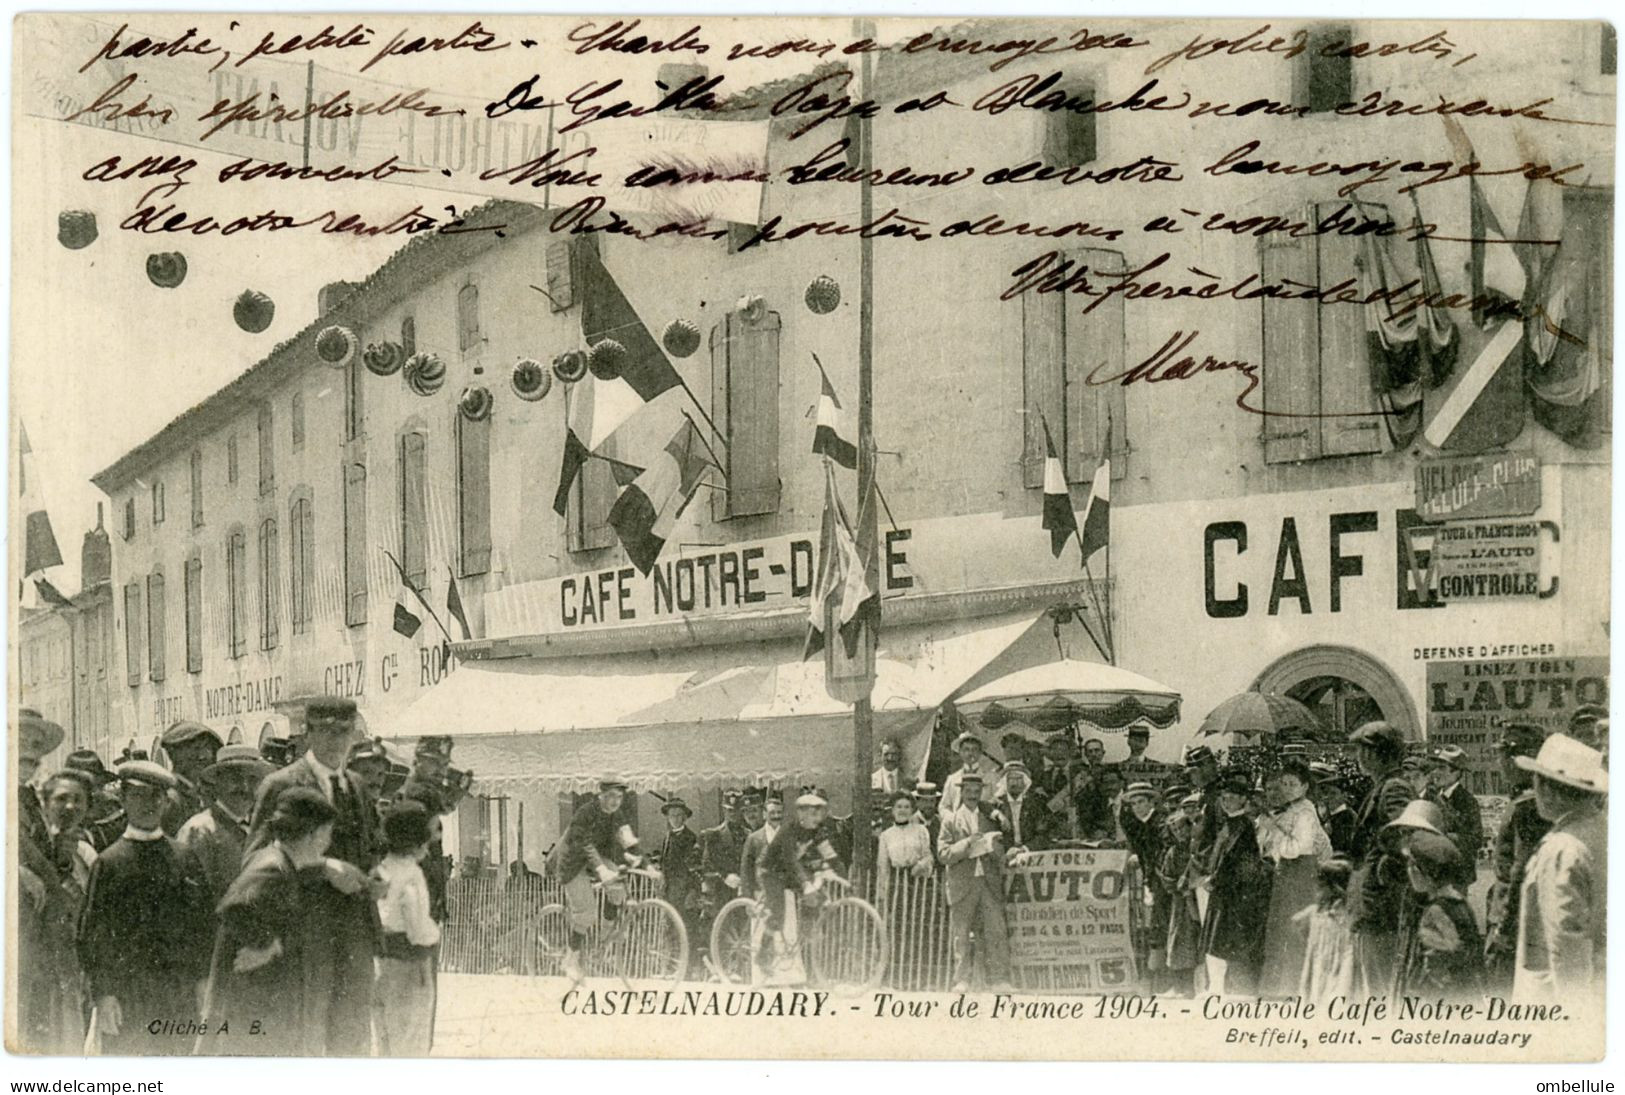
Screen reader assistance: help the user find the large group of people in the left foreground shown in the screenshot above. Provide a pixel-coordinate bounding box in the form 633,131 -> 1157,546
16,699 -> 465,1056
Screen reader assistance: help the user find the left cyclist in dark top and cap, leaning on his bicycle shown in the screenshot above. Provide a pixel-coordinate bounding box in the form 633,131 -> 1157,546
556,780 -> 642,981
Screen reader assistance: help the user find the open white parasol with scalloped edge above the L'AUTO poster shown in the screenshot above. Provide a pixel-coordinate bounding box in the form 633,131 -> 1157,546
954,661 -> 1180,731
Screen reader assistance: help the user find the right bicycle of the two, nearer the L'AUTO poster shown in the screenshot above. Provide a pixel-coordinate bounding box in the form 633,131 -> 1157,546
709,872 -> 889,996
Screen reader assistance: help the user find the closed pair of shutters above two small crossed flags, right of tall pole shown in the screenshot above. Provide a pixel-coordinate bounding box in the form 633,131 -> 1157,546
1021,247 -> 1128,487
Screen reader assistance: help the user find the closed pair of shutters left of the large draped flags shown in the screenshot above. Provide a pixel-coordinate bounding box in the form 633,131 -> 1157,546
1259,201 -> 1388,463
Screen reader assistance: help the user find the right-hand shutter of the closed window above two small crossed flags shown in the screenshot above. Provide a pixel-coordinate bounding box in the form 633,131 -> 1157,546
1059,249 -> 1128,483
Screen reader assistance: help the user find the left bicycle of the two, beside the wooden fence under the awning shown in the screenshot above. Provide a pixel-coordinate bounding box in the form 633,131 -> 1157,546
536,868 -> 689,985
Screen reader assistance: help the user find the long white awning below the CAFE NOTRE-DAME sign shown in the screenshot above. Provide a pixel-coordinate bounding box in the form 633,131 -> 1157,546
384,609 -> 1048,790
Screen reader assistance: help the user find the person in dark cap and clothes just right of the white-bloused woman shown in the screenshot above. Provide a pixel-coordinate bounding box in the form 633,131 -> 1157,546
1349,720 -> 1414,994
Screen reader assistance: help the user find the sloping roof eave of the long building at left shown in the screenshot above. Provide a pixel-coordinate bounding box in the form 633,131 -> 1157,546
91,200 -> 551,496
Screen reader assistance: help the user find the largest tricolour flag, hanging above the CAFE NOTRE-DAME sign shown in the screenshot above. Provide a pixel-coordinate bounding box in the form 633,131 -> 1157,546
553,247 -> 683,517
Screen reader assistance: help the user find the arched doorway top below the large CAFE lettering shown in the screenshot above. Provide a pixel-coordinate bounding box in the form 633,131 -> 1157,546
1253,647 -> 1420,741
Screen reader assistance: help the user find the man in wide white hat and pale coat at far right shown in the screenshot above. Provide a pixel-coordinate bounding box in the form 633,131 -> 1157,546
1513,734 -> 1609,1002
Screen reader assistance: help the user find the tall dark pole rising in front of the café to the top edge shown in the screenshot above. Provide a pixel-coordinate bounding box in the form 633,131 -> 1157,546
851,19 -> 881,894
